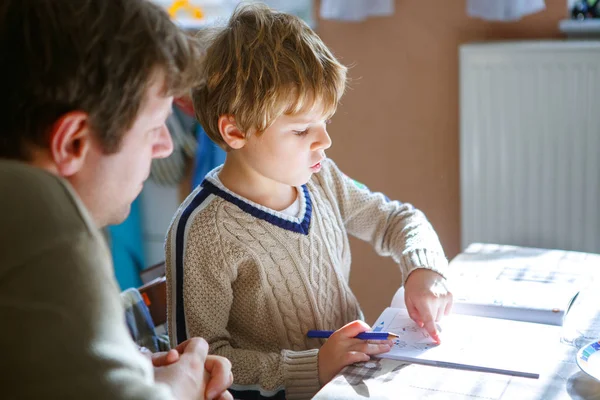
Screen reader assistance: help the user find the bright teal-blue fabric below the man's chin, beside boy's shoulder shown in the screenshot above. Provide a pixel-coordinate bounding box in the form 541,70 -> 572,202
108,197 -> 146,290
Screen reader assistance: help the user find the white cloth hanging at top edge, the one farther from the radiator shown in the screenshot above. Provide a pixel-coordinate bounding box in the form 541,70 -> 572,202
320,0 -> 394,21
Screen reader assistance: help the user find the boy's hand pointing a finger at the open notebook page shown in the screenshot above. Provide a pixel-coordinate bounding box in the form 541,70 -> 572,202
404,268 -> 452,343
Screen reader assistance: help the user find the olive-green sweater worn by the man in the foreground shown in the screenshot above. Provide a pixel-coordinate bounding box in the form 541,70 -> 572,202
0,160 -> 173,400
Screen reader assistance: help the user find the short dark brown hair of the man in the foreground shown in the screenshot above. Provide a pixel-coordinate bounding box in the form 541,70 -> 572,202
0,0 -> 198,160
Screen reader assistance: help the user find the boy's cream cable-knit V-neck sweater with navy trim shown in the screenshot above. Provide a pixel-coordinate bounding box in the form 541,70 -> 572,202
166,160 -> 448,399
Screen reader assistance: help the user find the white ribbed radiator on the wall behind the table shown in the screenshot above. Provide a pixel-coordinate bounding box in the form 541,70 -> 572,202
460,41 -> 600,253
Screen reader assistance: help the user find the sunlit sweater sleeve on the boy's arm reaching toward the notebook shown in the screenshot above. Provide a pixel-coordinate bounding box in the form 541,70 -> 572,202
318,159 -> 448,284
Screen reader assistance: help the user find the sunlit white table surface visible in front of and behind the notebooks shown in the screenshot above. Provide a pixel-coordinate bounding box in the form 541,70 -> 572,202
313,245 -> 600,400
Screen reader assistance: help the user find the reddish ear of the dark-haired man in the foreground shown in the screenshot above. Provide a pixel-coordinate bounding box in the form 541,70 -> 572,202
50,111 -> 92,177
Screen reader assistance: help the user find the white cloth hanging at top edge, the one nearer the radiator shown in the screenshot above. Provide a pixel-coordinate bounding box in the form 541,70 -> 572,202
467,0 -> 546,21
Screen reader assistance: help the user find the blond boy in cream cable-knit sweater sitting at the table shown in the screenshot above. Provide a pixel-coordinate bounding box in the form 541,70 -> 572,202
166,5 -> 452,399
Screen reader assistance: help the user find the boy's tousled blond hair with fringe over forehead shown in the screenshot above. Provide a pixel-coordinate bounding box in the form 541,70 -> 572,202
192,4 -> 346,150
